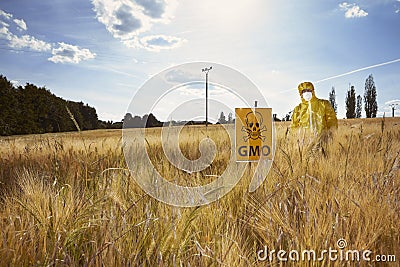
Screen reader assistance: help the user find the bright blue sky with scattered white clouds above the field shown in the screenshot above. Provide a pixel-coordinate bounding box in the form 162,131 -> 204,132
0,0 -> 400,121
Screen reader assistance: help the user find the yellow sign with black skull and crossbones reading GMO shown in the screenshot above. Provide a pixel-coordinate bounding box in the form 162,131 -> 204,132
235,108 -> 273,161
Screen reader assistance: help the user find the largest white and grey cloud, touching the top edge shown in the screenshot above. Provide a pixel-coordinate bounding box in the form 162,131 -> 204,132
92,0 -> 184,51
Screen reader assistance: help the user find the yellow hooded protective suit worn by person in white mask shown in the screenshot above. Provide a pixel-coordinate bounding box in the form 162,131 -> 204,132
292,82 -> 338,134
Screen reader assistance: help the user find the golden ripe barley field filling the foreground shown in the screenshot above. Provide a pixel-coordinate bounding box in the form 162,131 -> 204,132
0,118 -> 400,266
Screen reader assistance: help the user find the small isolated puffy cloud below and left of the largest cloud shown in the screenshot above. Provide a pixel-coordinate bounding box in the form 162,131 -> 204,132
48,42 -> 96,64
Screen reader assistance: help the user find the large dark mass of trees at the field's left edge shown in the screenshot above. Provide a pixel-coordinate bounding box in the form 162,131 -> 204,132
0,75 -> 108,135
